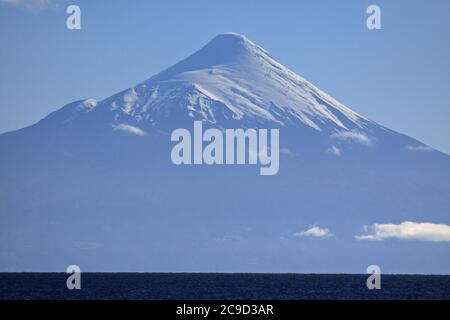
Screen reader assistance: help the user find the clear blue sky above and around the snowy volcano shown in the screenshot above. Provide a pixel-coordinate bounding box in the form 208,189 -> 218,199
0,0 -> 450,153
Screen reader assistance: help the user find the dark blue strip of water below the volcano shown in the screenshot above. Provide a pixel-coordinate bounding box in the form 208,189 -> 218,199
0,273 -> 450,300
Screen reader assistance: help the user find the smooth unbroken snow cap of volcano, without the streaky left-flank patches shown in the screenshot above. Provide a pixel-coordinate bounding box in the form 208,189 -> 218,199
145,33 -> 366,130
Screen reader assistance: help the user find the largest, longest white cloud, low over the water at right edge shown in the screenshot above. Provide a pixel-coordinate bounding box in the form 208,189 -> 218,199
355,221 -> 450,241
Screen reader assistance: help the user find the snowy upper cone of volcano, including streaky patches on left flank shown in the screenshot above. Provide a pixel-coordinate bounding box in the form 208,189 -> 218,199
69,33 -> 371,135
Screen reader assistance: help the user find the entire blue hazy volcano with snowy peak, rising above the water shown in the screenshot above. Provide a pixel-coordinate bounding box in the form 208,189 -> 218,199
0,33 -> 450,273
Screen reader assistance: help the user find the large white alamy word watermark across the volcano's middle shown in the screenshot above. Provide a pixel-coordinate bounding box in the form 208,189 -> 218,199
171,121 -> 280,175
